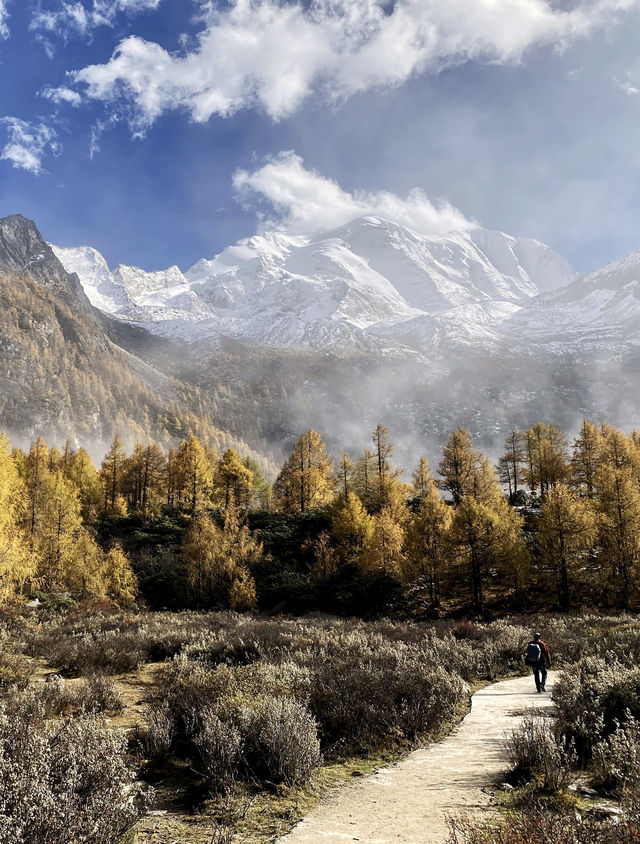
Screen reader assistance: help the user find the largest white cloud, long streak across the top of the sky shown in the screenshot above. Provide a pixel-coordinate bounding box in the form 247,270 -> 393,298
60,0 -> 640,132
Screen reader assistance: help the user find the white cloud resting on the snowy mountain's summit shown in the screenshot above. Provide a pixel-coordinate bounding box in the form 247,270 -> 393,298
233,151 -> 474,234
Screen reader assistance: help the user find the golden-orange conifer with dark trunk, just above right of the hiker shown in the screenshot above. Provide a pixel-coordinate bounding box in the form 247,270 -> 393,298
538,484 -> 596,609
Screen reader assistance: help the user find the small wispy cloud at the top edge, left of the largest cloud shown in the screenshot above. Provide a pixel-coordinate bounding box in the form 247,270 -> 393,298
32,0 -> 161,38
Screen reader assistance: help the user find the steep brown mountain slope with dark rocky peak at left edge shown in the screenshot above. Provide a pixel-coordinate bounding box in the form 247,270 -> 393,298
0,211 -> 270,456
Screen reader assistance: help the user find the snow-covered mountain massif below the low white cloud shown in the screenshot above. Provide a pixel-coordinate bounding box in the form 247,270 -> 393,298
53,217 -> 575,351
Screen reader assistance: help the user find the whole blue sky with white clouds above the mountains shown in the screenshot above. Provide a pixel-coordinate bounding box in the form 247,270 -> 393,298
0,0 -> 640,271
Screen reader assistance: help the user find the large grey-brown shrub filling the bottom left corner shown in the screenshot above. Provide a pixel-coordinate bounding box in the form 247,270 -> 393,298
0,706 -> 145,844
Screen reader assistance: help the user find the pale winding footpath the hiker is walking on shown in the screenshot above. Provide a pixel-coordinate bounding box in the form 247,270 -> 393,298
279,674 -> 553,844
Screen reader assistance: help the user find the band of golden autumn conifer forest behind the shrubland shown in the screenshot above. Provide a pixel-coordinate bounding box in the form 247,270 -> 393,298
0,420 -> 640,619
